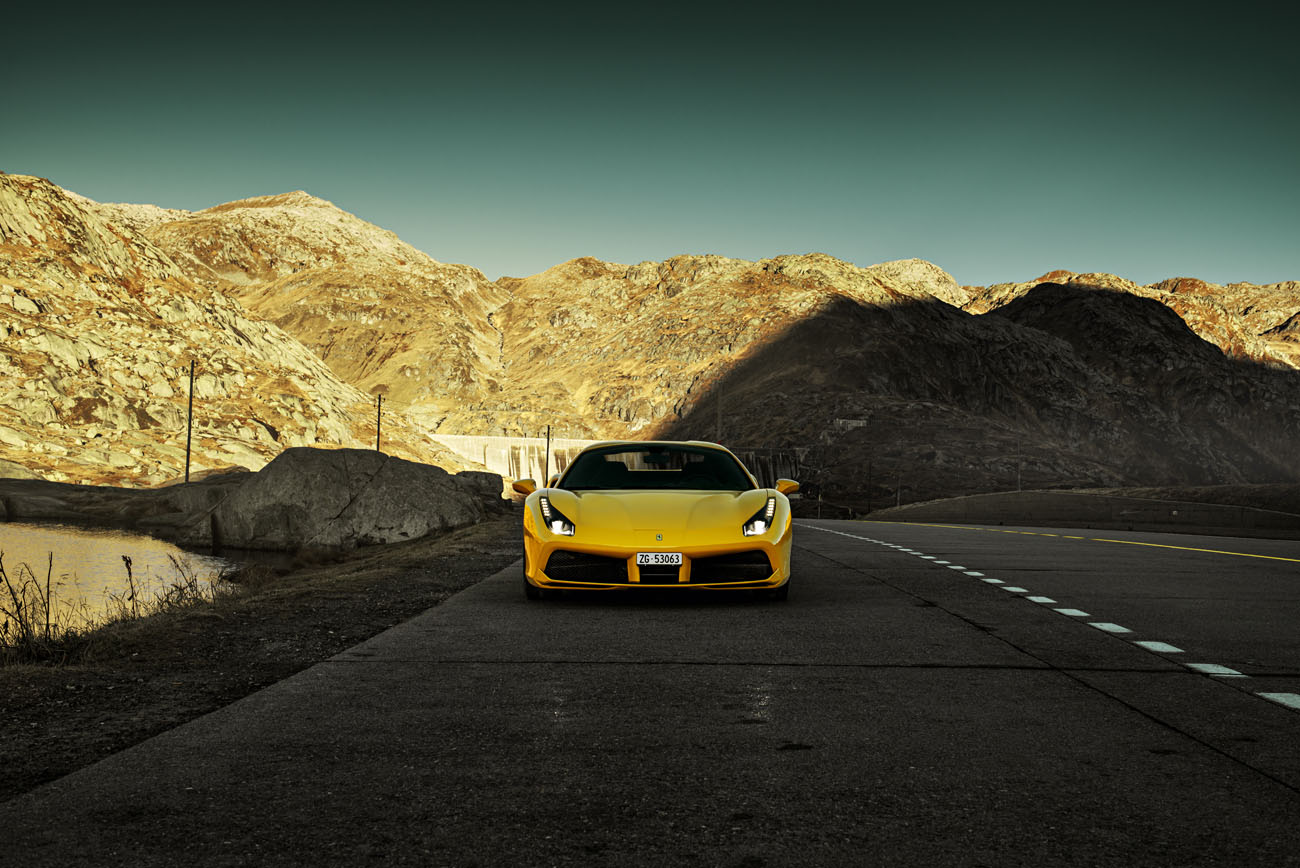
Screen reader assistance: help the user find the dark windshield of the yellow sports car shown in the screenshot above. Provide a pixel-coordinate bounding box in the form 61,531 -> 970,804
558,443 -> 754,491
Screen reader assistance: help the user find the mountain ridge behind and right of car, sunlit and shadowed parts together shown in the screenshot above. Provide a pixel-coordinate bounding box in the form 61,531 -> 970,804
457,255 -> 1300,508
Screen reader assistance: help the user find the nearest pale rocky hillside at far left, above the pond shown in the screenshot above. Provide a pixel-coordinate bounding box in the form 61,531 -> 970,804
0,174 -> 475,485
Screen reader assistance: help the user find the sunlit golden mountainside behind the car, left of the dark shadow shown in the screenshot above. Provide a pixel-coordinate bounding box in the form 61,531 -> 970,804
345,253 -> 966,439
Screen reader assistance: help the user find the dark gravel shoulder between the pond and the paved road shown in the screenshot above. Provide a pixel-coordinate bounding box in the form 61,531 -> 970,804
0,513 -> 519,802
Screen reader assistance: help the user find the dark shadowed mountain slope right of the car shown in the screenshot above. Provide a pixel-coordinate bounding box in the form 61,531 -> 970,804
662,285 -> 1300,509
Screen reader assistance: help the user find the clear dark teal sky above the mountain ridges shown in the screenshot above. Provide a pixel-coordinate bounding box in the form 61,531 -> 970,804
0,3 -> 1300,285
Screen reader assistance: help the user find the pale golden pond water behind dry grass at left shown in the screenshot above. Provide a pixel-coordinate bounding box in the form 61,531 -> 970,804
0,521 -> 230,624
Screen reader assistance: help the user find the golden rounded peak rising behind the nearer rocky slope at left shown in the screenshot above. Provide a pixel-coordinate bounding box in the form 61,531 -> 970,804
129,191 -> 504,429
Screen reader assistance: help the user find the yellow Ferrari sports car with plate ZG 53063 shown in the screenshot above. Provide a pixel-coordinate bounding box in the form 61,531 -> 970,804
514,440 -> 800,600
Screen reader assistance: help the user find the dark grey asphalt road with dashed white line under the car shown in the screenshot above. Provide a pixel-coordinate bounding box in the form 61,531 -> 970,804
0,521 -> 1300,867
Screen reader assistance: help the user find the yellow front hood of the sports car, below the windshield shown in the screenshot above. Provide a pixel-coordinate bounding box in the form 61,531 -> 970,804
549,489 -> 771,546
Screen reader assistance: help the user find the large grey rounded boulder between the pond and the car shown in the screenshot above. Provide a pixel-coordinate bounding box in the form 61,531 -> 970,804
169,447 -> 502,551
